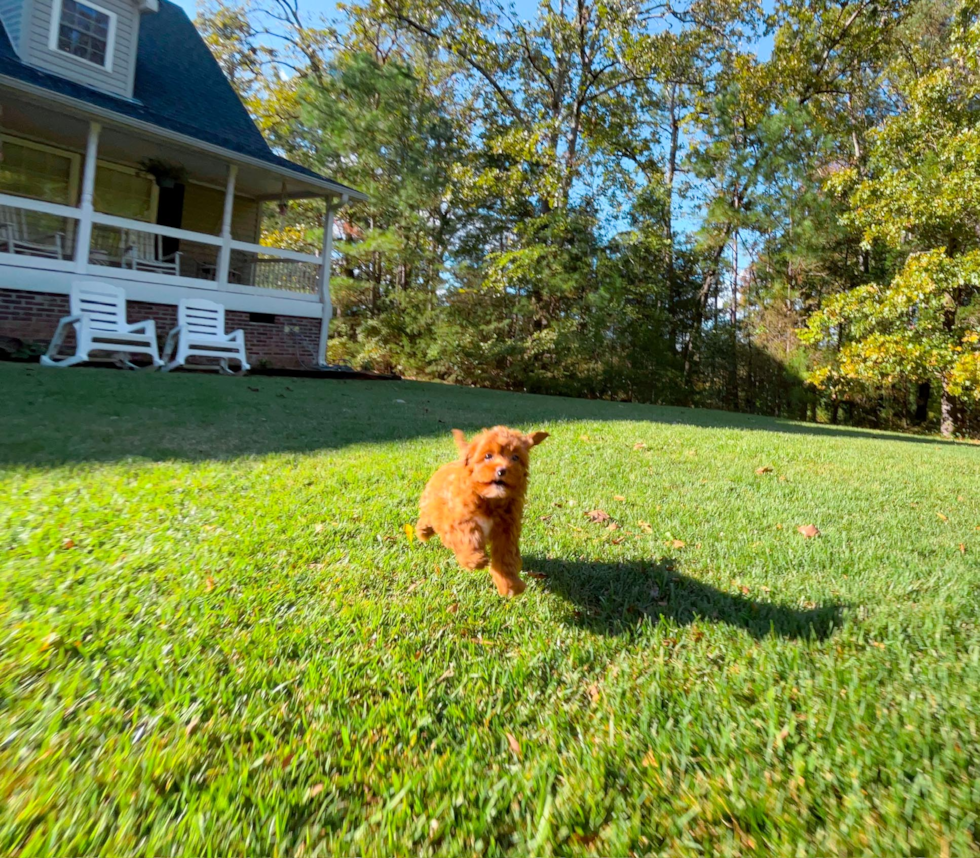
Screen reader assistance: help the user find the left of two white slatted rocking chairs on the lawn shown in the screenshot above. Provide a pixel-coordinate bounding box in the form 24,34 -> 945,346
41,281 -> 163,369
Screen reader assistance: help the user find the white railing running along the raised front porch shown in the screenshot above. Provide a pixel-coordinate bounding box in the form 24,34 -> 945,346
0,193 -> 323,296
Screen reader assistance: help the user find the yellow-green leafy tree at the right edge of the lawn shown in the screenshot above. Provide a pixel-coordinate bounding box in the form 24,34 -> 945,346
806,2 -> 980,435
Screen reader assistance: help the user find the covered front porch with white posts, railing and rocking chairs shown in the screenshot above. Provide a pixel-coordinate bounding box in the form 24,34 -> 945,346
0,92 -> 360,362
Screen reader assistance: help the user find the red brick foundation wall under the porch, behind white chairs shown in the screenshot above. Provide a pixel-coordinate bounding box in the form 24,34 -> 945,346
0,289 -> 320,369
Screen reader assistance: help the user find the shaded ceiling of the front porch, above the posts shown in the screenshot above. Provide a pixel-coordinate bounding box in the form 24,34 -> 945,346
0,92 -> 330,199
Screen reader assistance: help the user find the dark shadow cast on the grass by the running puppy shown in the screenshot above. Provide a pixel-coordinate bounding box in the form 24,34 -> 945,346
524,557 -> 843,640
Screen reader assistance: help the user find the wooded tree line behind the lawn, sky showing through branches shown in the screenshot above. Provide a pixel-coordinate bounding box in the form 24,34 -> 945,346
199,0 -> 980,431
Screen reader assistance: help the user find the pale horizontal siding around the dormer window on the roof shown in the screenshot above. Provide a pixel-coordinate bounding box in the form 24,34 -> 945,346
24,0 -> 139,97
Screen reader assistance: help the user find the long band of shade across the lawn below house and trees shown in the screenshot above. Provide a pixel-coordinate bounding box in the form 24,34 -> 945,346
0,363 -> 964,465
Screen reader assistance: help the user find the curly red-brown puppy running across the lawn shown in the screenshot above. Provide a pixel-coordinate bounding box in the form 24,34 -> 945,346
415,426 -> 548,596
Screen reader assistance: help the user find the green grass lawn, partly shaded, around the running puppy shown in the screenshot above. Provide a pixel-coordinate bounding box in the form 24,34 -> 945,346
0,364 -> 980,856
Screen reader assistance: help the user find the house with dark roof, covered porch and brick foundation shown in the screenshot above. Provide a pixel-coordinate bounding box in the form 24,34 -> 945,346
0,0 -> 365,367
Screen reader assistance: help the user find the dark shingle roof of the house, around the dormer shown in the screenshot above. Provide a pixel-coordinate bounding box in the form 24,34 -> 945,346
0,0 -> 356,193
